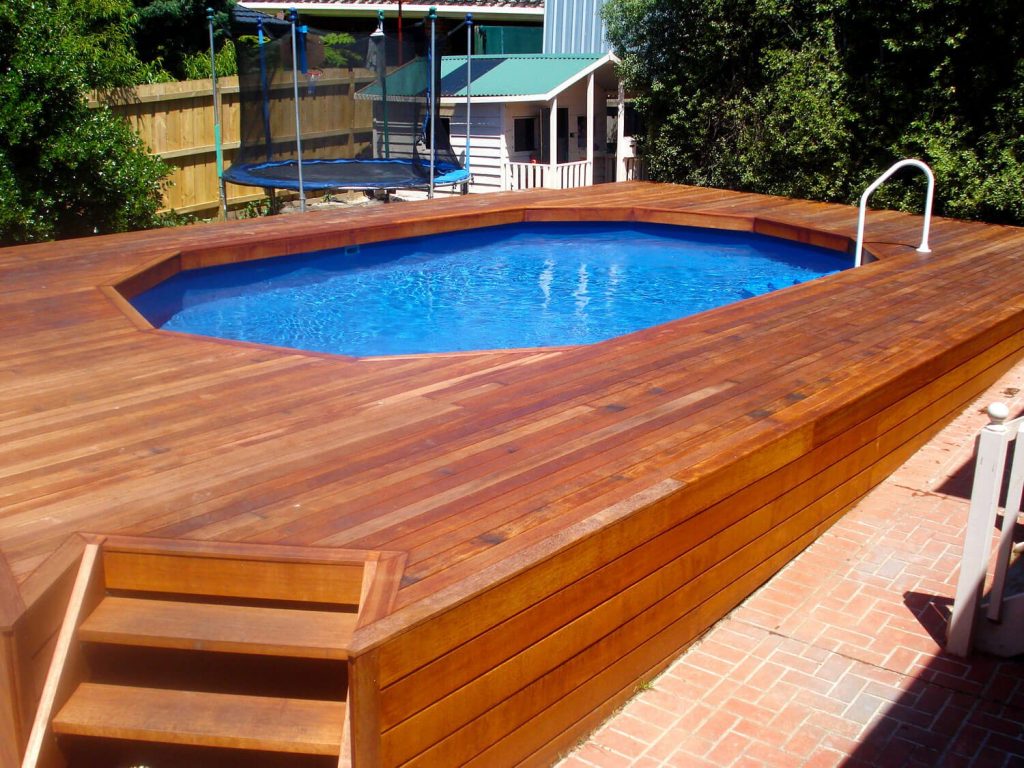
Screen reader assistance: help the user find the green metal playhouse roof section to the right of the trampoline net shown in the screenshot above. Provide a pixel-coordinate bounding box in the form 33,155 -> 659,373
440,53 -> 605,98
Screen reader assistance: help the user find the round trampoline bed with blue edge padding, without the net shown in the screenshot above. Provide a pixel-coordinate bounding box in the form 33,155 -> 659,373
224,158 -> 469,191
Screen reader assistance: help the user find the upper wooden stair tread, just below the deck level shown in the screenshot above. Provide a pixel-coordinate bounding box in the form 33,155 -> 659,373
79,596 -> 356,659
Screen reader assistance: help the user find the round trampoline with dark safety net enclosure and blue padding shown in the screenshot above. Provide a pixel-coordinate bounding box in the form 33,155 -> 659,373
224,10 -> 468,191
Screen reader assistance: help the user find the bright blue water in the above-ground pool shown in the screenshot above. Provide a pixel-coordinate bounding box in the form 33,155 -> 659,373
133,222 -> 851,356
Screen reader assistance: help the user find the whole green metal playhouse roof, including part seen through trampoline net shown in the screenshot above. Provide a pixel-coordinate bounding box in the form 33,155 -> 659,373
357,53 -> 608,100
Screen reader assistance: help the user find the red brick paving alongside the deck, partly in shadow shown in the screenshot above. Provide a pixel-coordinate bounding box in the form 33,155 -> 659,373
559,362 -> 1024,768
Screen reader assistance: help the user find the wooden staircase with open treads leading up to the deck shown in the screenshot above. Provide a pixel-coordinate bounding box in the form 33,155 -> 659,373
23,540 -> 387,768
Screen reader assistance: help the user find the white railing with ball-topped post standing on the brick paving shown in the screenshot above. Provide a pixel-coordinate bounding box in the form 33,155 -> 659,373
946,402 -> 1024,656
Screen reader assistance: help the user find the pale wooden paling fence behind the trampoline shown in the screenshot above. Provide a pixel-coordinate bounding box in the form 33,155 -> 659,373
90,70 -> 373,215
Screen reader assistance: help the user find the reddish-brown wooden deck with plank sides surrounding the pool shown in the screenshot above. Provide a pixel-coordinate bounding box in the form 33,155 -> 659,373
0,182 -> 1024,766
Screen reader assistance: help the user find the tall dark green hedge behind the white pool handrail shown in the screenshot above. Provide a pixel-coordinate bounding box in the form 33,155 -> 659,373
605,0 -> 1024,223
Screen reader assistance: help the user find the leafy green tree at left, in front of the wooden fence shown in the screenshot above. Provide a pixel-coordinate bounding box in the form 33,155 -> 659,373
0,0 -> 168,244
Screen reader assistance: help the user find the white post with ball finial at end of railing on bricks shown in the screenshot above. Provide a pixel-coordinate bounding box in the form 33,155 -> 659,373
946,402 -> 1010,656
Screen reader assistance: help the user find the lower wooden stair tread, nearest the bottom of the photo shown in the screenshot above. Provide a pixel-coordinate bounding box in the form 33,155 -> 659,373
53,683 -> 346,756
